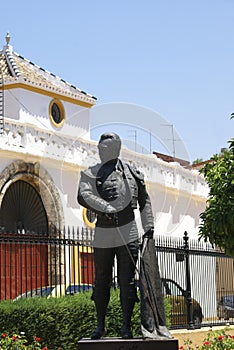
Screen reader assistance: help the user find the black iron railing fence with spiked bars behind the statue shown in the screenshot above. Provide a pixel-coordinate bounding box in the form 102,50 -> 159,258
0,228 -> 234,328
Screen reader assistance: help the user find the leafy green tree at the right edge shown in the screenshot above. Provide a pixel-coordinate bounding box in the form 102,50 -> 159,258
199,115 -> 234,258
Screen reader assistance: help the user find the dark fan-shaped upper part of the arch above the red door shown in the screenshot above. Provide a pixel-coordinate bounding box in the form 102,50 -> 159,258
0,180 -> 48,234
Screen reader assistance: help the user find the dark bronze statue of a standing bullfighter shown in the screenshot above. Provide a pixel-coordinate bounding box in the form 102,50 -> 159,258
78,133 -> 171,339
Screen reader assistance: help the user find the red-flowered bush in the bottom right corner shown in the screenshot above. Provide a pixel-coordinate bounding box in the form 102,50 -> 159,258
179,327 -> 234,350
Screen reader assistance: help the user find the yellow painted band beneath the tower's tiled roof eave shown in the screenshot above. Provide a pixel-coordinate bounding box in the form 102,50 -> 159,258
0,83 -> 94,108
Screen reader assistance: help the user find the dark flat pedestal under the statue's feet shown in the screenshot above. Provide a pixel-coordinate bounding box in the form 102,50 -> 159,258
78,338 -> 179,350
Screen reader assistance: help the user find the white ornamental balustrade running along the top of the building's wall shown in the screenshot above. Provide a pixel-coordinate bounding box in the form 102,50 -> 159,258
0,120 -> 209,199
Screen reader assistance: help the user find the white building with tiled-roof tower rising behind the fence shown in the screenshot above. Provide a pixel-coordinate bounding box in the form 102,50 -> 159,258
0,35 -> 208,237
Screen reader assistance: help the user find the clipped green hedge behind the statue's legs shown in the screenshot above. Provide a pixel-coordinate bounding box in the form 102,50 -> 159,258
0,291 -> 170,350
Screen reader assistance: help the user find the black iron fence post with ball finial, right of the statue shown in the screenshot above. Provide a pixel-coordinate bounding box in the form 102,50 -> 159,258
183,231 -> 194,329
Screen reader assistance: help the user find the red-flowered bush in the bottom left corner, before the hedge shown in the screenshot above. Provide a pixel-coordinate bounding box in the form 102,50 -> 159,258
0,333 -> 48,350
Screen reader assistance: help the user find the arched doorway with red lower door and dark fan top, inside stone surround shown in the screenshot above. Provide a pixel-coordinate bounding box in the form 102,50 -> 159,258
0,180 -> 48,300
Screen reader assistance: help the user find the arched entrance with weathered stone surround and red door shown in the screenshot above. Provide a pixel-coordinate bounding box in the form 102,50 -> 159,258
0,161 -> 64,299
